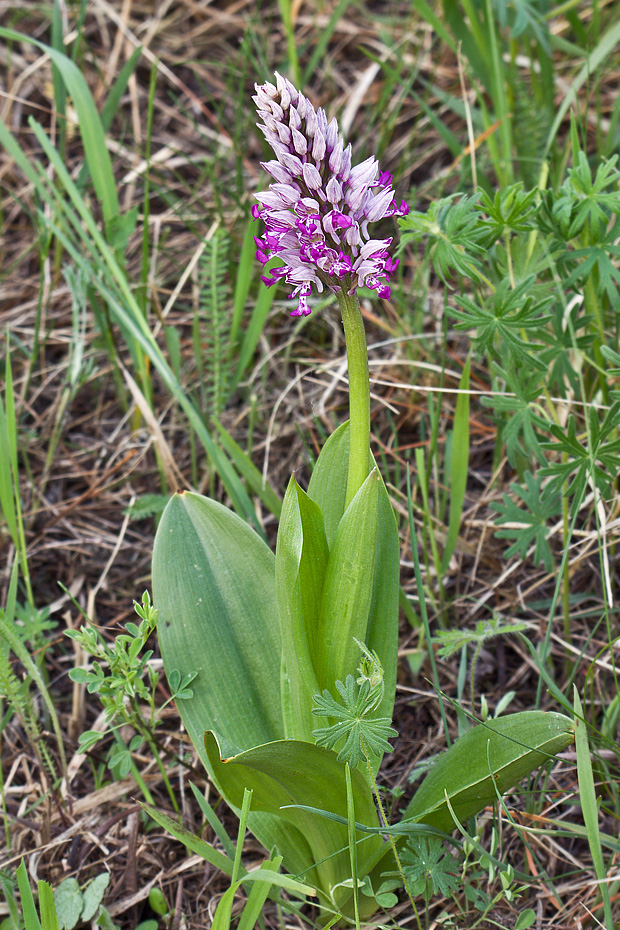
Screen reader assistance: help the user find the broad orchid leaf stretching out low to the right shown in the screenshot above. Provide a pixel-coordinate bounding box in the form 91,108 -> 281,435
403,711 -> 574,832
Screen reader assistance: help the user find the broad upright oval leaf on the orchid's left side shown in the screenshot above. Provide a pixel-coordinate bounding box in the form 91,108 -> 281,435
153,494 -> 284,764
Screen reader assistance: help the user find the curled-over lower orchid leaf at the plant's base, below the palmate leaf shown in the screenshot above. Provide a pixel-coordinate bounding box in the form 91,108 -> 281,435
205,732 -> 383,907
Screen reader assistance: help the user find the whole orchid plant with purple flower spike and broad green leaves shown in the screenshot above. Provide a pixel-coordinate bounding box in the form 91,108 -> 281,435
153,74 -> 572,921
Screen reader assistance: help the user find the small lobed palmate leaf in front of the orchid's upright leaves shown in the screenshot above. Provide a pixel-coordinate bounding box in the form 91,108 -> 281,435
312,675 -> 398,769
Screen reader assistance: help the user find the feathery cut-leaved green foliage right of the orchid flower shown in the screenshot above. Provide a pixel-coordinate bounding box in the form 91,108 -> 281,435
399,150 -> 620,588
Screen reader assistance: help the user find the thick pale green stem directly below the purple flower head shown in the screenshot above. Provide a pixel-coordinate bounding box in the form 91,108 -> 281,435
338,291 -> 370,507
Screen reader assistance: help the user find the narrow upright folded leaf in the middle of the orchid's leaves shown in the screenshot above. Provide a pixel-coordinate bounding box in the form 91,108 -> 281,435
276,476 -> 329,742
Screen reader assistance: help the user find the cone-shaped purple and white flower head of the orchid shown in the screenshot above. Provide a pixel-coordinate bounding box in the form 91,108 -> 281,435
252,72 -> 409,316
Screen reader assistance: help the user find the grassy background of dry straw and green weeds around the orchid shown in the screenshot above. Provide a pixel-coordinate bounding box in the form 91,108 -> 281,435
0,0 -> 620,930
